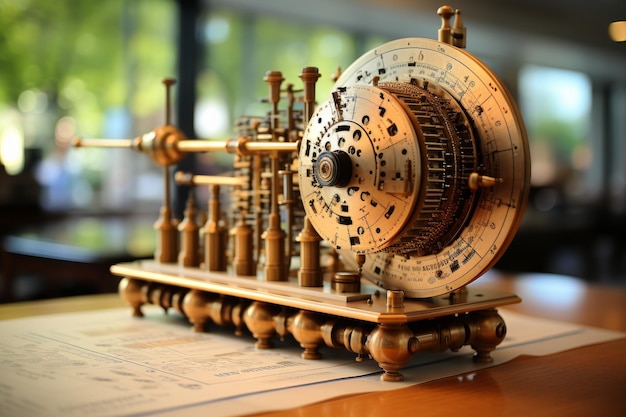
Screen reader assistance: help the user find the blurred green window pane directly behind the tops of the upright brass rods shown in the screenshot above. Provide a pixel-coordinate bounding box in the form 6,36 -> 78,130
196,10 -> 357,138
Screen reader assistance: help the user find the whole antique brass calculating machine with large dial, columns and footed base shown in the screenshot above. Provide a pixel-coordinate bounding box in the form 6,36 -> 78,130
75,6 -> 530,381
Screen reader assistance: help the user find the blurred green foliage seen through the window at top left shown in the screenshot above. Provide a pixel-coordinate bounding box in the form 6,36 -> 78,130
0,0 -> 175,134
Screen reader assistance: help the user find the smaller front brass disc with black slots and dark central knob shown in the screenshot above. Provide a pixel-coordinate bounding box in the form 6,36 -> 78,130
299,84 -> 420,253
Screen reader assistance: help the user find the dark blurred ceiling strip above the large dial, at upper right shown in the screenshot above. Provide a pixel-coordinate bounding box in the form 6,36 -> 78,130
205,0 -> 626,81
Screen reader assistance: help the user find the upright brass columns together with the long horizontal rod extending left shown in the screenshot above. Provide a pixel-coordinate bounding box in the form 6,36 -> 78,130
74,67 -> 323,287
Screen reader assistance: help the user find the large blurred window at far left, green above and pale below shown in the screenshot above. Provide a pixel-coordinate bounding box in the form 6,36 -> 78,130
0,0 -> 176,211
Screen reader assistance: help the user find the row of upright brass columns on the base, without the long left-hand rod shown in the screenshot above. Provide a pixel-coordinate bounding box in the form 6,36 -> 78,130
163,67 -> 323,287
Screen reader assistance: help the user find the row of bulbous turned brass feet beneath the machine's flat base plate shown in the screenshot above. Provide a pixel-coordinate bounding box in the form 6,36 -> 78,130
120,278 -> 506,381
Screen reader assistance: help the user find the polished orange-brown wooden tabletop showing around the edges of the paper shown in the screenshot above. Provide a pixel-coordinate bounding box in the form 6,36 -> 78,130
0,274 -> 626,417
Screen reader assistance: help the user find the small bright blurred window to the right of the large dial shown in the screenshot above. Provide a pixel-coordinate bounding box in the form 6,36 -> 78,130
519,66 -> 588,210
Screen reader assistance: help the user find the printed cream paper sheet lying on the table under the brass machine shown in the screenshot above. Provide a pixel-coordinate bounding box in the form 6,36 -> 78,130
0,306 -> 624,417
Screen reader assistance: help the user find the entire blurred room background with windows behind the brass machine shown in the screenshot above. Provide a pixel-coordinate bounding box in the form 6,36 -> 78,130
0,0 -> 626,301
